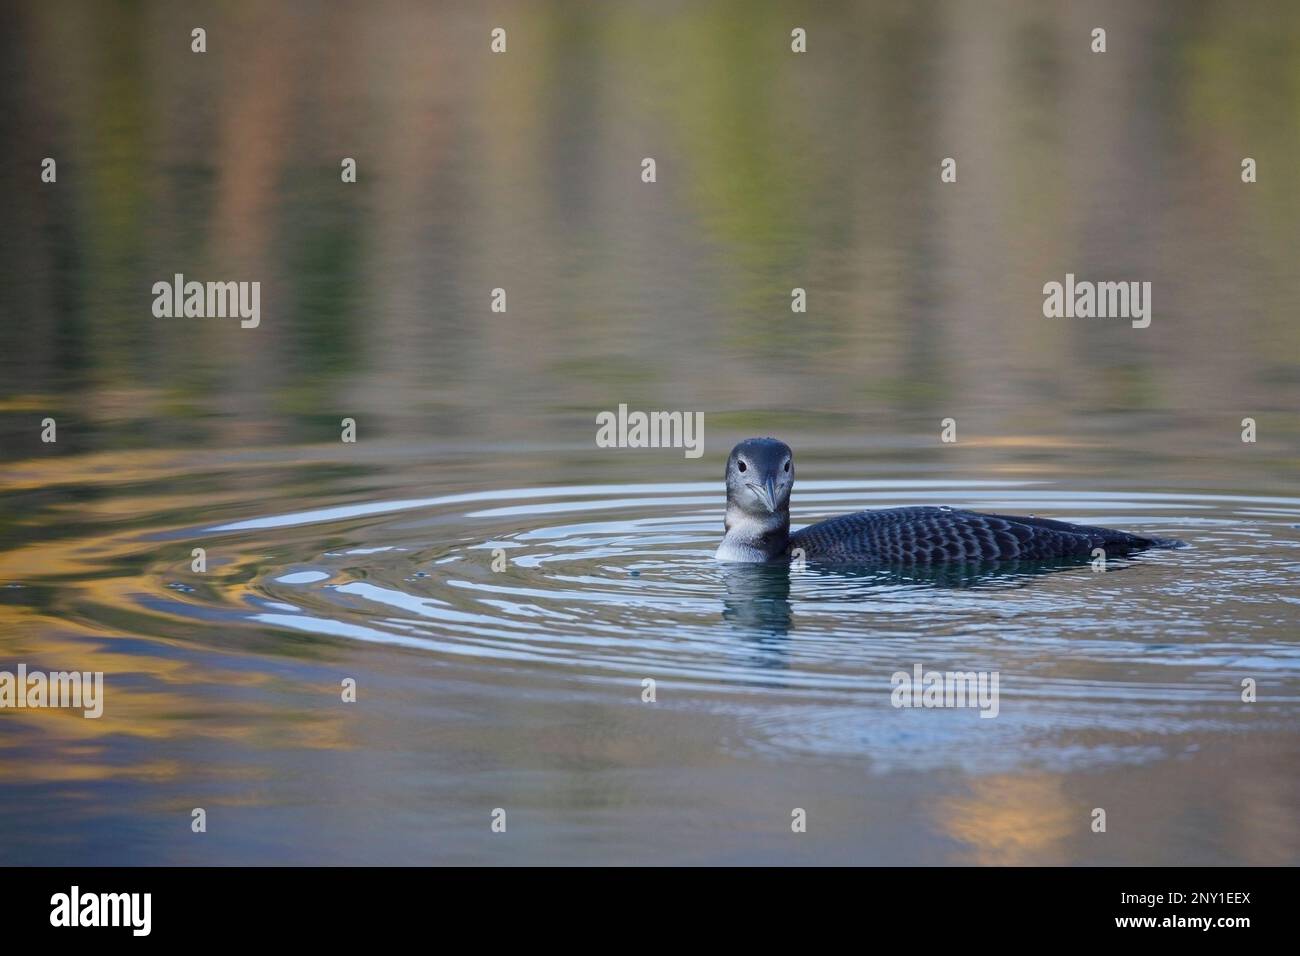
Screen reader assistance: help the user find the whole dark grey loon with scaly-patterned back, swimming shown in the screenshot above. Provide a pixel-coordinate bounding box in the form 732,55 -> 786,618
714,438 -> 1182,564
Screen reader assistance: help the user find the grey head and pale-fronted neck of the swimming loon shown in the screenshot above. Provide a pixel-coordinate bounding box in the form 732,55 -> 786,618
715,438 -> 794,561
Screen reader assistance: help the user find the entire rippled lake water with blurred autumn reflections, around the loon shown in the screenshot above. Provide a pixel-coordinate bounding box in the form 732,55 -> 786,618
0,3 -> 1300,865
